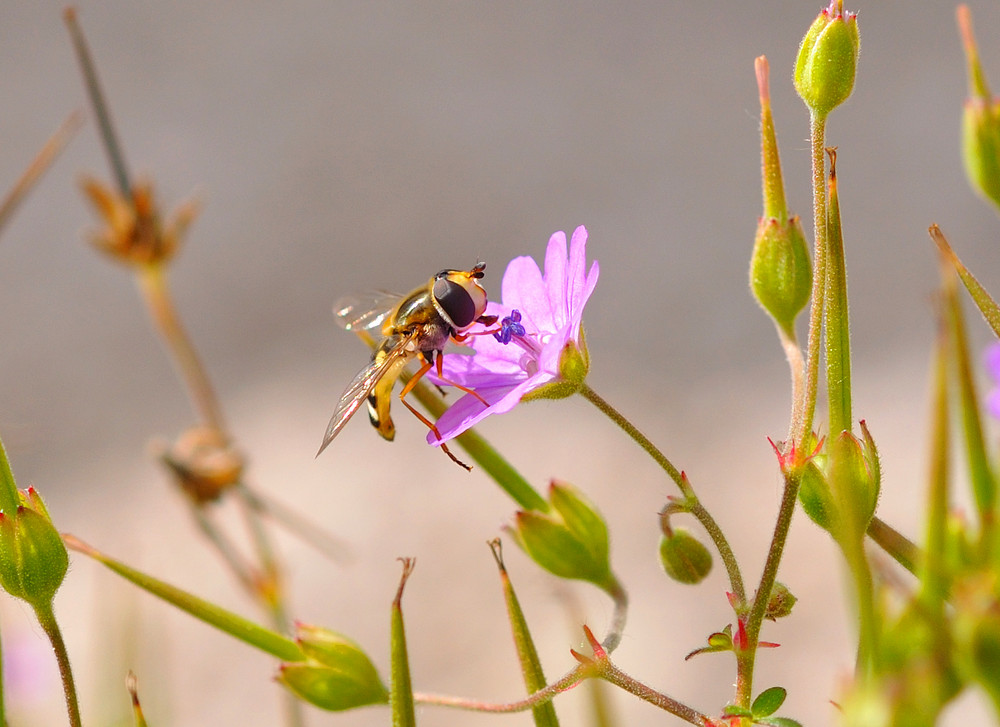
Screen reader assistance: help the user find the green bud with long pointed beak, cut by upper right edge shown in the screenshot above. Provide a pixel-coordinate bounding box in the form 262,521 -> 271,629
958,5 -> 1000,206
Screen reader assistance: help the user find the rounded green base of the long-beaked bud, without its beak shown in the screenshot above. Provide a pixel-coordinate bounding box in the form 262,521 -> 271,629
750,216 -> 812,335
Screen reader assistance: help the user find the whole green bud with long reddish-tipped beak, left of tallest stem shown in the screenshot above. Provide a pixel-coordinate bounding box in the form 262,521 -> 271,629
750,56 -> 812,338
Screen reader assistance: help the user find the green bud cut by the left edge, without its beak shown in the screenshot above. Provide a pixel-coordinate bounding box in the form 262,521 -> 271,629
0,488 -> 69,608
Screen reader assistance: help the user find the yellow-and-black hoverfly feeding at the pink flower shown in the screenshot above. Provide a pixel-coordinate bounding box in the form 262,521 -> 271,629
316,263 -> 496,469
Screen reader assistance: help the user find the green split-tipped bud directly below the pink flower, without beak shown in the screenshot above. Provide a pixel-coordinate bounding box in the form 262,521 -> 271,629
511,480 -> 616,590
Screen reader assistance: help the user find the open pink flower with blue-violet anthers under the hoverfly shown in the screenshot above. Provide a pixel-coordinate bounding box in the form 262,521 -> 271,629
427,227 -> 600,444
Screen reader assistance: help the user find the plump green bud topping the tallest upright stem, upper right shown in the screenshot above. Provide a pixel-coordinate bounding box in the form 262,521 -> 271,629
794,0 -> 861,118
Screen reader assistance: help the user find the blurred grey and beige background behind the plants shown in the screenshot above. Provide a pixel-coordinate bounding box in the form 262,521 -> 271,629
0,0 -> 1000,727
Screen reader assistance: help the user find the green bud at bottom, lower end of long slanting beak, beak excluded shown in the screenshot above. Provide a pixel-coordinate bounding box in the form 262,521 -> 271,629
278,624 -> 389,712
